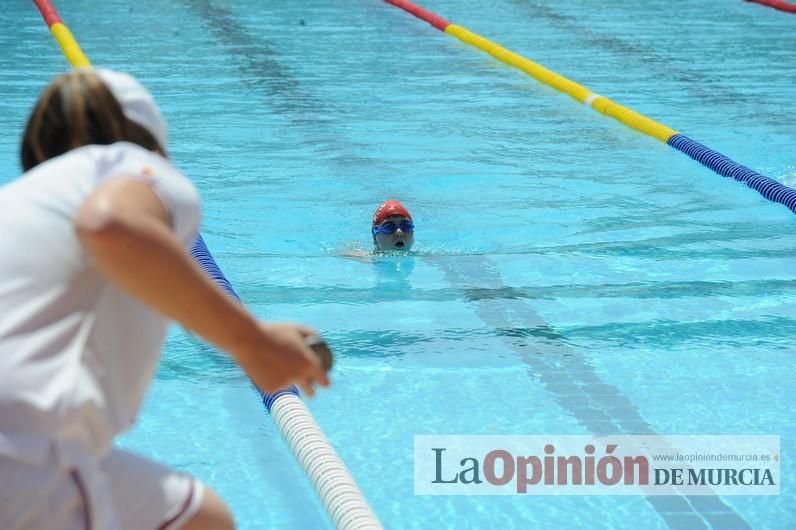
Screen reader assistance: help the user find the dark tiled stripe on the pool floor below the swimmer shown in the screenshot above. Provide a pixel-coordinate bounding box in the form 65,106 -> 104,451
425,252 -> 751,530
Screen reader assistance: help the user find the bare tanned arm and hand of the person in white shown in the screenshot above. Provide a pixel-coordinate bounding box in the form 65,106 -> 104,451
74,178 -> 329,395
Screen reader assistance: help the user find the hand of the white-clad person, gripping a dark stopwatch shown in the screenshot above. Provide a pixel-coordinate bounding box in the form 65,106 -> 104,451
238,323 -> 329,397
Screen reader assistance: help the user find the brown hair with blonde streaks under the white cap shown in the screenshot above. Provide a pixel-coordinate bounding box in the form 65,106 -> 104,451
20,70 -> 165,171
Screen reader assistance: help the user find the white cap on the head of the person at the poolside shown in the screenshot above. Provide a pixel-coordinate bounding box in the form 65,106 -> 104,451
94,68 -> 168,151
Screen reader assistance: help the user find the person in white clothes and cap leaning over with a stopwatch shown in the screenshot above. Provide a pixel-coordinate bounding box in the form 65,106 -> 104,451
0,70 -> 329,530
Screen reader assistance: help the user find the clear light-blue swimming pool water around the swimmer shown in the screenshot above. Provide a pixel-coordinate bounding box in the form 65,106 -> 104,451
0,0 -> 796,530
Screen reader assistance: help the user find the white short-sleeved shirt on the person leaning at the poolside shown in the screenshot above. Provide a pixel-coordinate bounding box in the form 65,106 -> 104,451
0,142 -> 199,461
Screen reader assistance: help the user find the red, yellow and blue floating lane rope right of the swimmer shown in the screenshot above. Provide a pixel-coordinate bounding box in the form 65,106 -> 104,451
384,0 -> 796,213
